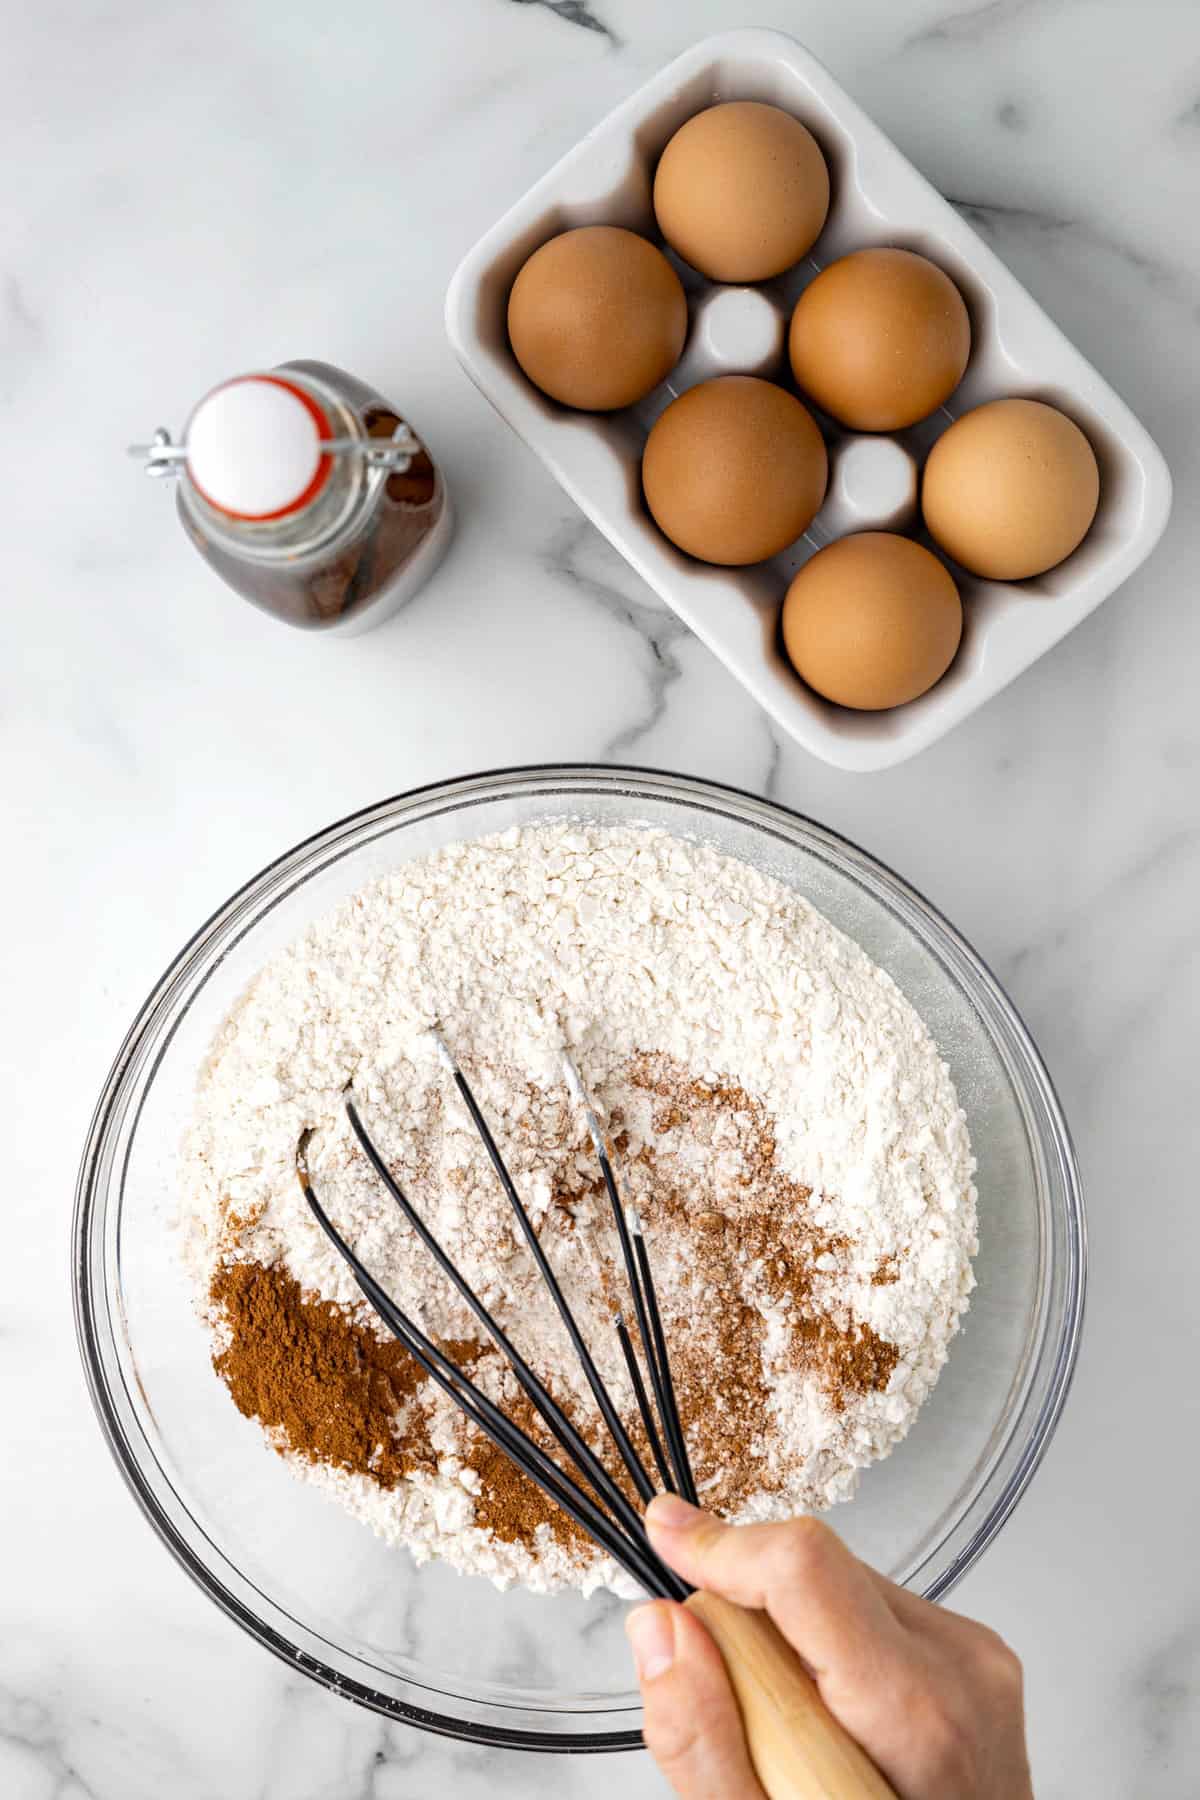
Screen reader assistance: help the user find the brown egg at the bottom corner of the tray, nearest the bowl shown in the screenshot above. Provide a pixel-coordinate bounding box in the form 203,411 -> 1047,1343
783,531 -> 963,713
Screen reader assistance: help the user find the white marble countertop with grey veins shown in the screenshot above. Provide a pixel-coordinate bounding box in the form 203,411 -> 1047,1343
0,0 -> 1200,1800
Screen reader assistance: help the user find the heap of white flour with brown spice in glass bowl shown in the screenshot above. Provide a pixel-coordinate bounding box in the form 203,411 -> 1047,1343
184,824 -> 977,1591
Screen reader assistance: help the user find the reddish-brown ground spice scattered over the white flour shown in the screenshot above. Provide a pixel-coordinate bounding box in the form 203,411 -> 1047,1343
210,1055 -> 898,1550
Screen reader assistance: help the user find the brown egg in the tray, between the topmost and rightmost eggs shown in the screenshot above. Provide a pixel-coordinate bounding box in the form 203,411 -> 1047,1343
788,248 -> 972,432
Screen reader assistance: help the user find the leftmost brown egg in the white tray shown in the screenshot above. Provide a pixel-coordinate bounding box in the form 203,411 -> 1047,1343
509,225 -> 687,412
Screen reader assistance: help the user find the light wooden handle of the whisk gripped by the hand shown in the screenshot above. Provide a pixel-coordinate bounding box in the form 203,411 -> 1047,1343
685,1593 -> 896,1800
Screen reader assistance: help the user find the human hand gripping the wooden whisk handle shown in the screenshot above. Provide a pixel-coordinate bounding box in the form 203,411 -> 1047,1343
628,1496 -> 1033,1800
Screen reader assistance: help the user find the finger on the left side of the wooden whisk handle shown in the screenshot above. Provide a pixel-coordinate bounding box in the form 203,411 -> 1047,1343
626,1600 -> 766,1800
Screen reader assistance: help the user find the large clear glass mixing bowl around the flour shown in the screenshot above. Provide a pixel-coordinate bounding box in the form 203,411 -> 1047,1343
74,767 -> 1085,1751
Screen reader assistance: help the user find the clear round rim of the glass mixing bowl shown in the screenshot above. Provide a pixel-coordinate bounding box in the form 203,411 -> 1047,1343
72,761 -> 1087,1755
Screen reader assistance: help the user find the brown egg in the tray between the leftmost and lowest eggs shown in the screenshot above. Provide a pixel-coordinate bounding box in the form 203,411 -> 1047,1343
642,374 -> 828,565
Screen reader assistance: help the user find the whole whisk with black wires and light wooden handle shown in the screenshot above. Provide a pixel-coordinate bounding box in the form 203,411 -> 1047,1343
297,1033 -> 894,1800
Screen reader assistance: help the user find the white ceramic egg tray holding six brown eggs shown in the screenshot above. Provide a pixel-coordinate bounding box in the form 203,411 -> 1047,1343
446,31 -> 1171,770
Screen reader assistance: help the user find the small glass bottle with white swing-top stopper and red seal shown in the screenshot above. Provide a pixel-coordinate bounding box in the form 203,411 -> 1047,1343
139,362 -> 452,635
